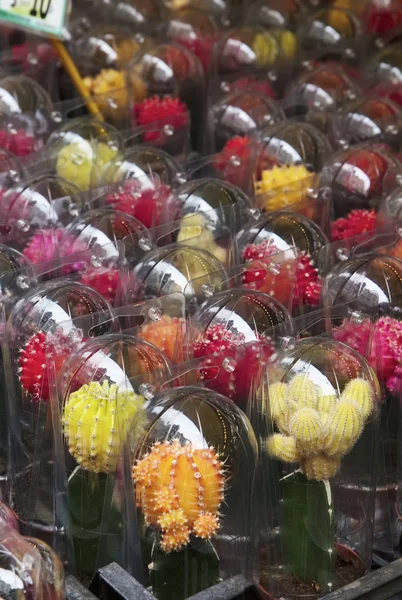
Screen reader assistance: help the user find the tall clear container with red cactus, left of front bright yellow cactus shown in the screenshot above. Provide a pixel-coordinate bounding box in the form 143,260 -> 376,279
3,280 -> 115,558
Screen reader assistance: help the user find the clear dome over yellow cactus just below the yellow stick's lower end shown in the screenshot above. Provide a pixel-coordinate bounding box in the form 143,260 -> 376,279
46,117 -> 123,191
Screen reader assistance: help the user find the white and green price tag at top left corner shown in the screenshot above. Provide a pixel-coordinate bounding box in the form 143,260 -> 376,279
0,0 -> 68,37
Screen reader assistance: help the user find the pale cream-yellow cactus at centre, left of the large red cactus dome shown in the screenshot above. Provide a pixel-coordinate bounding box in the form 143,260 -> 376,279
177,213 -> 228,264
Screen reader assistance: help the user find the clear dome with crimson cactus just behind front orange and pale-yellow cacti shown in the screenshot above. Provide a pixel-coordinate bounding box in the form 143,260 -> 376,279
192,289 -> 293,414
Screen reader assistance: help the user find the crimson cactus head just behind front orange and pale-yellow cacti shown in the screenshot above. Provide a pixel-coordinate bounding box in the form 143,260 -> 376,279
193,324 -> 274,404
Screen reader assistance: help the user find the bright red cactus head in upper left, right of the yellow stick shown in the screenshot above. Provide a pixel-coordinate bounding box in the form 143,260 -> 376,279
134,96 -> 190,142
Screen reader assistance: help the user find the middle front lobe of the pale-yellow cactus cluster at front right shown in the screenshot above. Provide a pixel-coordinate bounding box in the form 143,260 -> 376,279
289,408 -> 324,456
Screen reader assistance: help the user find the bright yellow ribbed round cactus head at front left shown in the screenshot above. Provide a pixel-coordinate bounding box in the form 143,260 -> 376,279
63,381 -> 144,473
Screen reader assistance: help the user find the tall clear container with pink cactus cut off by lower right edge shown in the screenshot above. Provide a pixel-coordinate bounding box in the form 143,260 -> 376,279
326,254 -> 402,562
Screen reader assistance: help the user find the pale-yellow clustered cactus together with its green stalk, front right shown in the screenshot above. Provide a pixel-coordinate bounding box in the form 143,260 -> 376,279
266,372 -> 375,593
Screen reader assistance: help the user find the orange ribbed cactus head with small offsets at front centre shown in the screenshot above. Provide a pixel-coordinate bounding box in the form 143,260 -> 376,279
133,439 -> 225,553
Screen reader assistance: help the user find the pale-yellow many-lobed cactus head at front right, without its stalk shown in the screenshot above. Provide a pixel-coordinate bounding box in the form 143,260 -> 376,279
267,373 -> 374,481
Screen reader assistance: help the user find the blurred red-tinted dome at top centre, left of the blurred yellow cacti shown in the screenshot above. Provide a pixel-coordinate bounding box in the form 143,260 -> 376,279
166,8 -> 219,73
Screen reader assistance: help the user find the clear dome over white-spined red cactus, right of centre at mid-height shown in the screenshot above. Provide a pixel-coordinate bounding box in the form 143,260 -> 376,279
237,211 -> 328,313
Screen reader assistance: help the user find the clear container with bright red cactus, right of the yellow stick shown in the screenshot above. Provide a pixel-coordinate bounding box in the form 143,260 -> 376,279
127,43 -> 205,154
